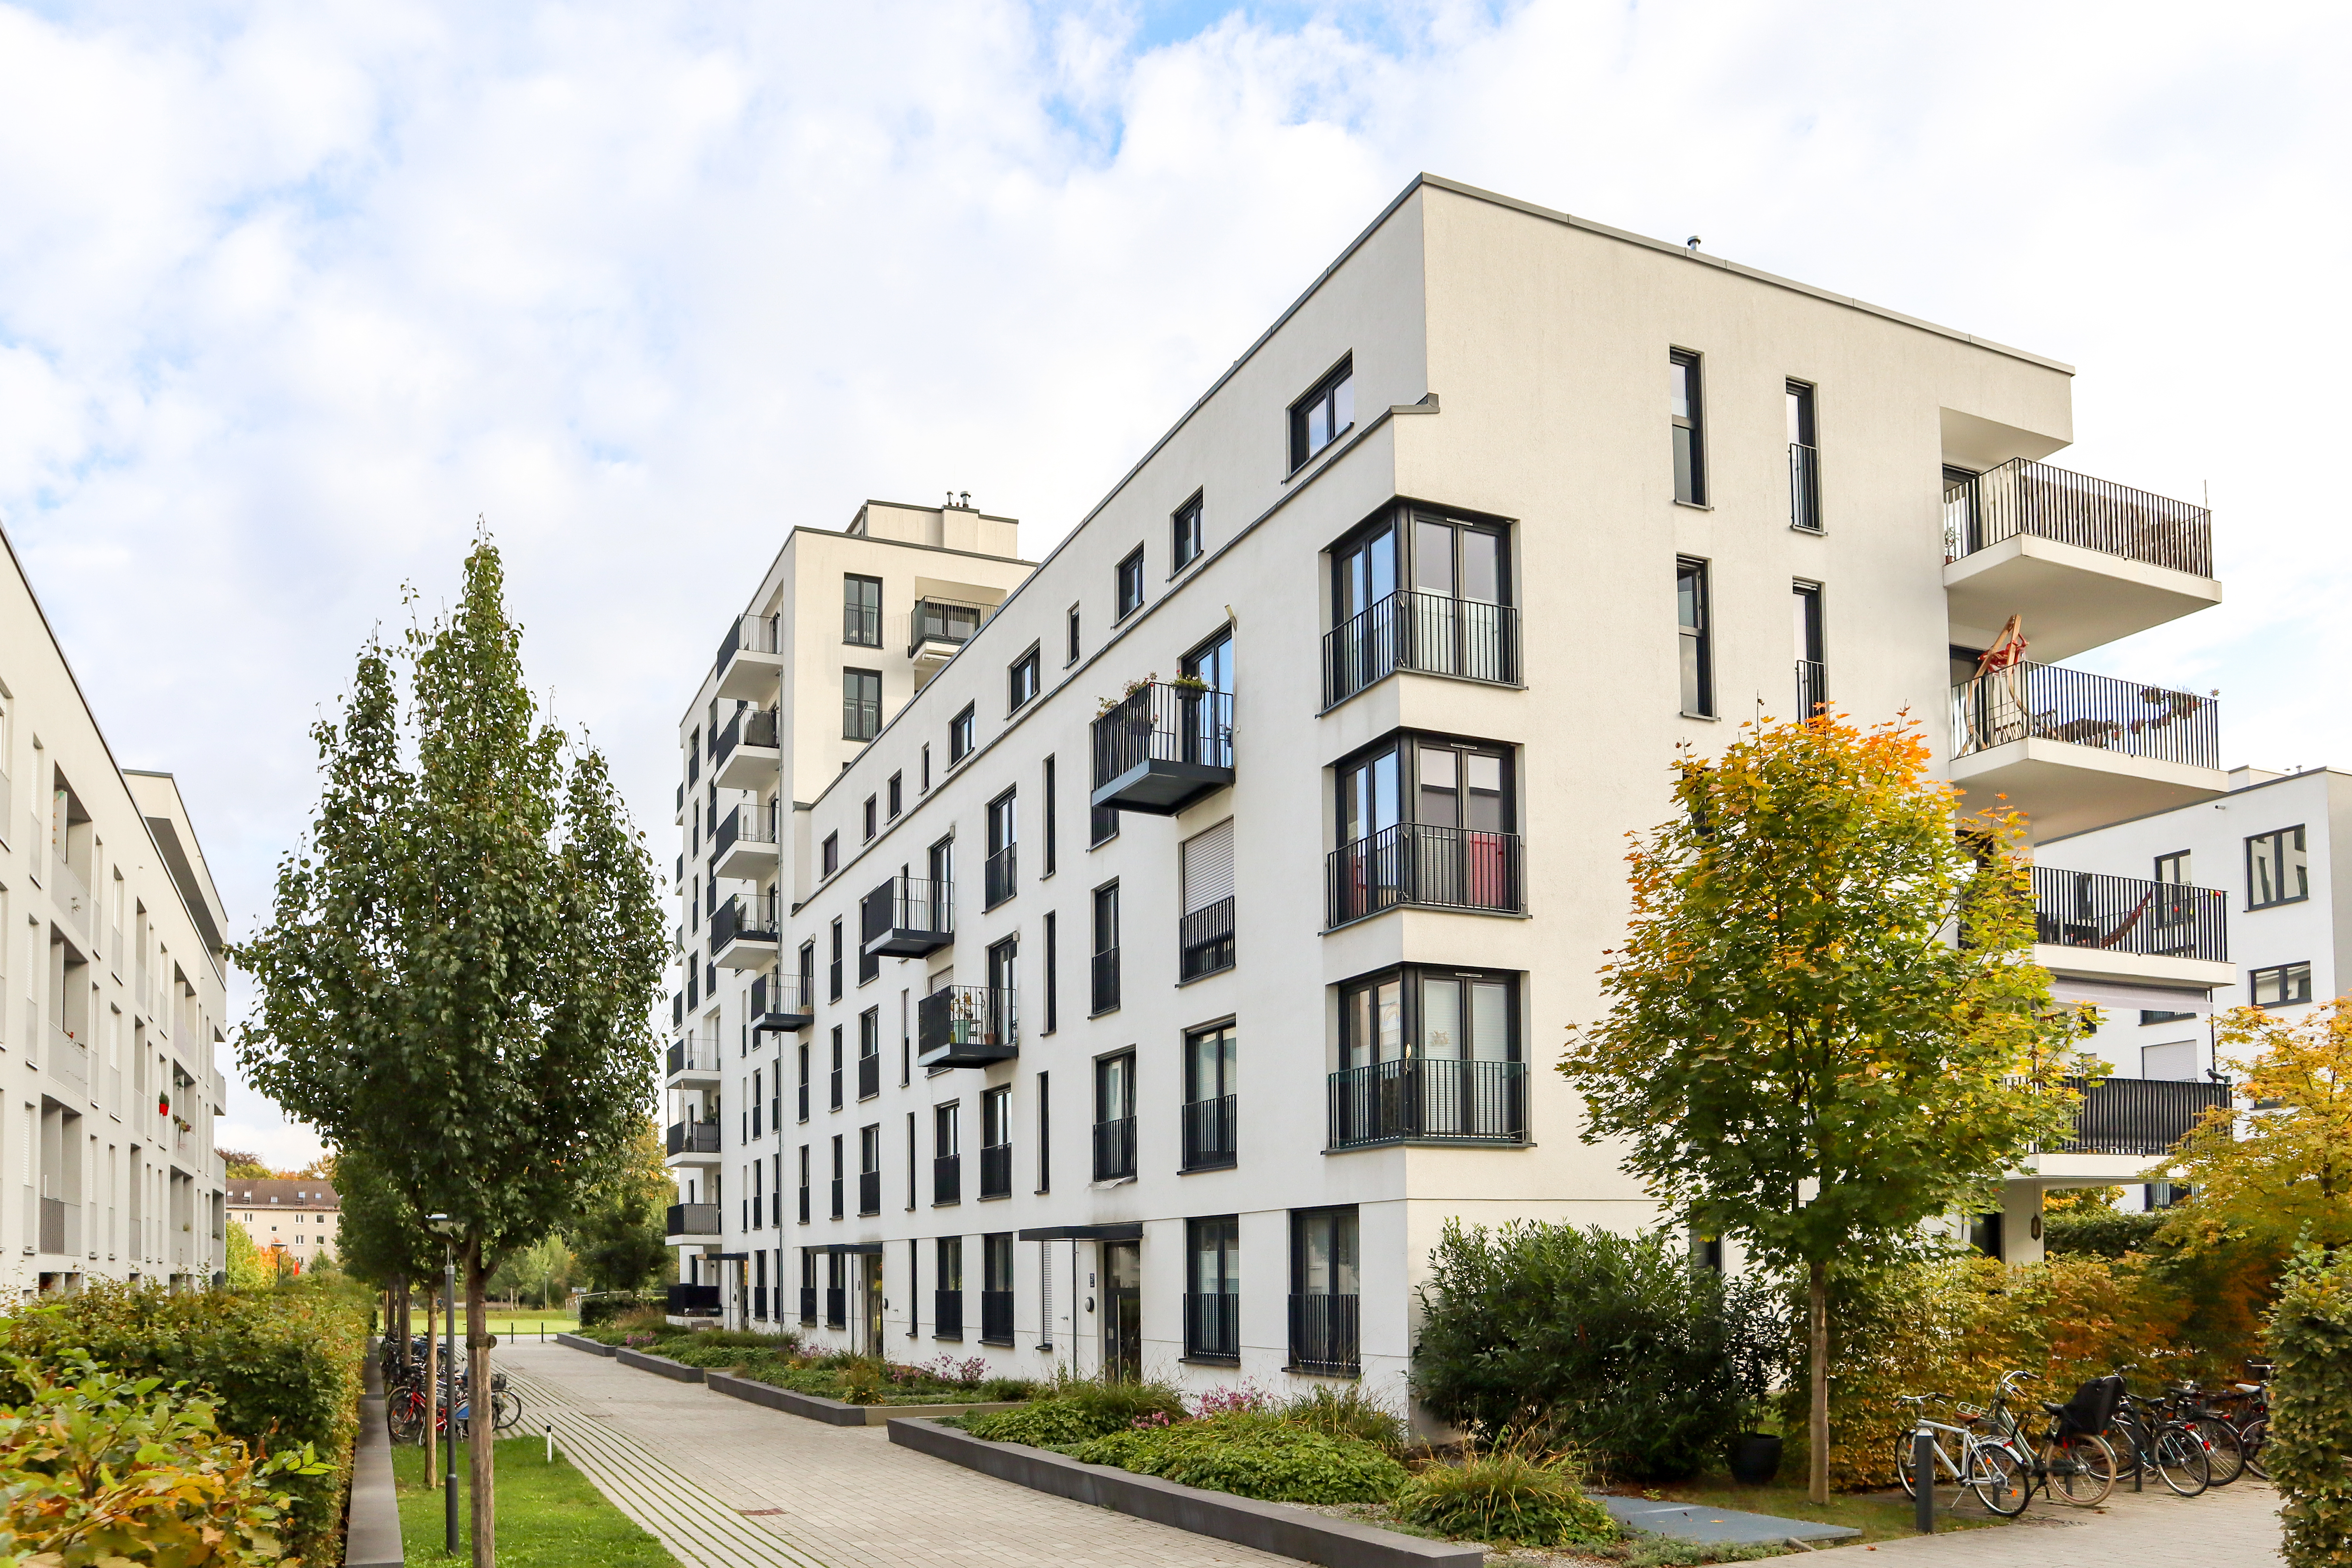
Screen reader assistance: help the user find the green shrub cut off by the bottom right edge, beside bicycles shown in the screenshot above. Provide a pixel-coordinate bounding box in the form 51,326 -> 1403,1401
2263,1248 -> 2352,1568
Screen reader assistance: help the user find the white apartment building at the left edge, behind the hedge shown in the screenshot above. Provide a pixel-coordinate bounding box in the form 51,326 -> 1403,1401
0,522 -> 228,1300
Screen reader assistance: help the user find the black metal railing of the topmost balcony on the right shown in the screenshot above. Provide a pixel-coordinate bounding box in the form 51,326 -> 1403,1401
1943,458 -> 2213,576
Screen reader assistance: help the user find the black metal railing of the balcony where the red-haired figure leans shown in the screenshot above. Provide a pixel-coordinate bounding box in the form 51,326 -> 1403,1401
1952,663 -> 2220,769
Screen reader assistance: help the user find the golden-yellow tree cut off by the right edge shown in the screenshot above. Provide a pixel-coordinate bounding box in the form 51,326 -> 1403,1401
2164,995 -> 2352,1258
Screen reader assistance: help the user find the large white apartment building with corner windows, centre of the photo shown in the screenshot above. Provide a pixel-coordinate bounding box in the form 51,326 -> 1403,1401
666,176 -> 2225,1392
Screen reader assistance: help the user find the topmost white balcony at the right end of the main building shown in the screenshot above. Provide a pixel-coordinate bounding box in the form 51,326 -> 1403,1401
1943,458 -> 2220,658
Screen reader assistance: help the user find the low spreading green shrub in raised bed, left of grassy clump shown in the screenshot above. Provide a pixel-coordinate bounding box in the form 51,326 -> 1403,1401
1070,1413 -> 1406,1502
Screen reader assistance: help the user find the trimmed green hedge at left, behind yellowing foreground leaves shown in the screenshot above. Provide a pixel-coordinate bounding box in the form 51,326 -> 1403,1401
0,1274 -> 372,1563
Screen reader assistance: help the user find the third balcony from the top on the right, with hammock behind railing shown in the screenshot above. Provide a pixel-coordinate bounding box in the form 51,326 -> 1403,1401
2034,865 -> 2237,987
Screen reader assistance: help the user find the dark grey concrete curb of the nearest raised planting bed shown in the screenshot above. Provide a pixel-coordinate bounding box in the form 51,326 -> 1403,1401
889,1417 -> 1486,1568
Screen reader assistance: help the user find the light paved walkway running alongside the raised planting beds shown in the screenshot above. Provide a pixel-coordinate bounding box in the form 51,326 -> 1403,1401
499,1340 -> 1298,1568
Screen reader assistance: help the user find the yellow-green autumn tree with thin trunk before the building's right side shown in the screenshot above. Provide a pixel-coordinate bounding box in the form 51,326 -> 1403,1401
1559,715 -> 2079,1502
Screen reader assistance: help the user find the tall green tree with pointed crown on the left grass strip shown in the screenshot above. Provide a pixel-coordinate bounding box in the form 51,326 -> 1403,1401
235,538 -> 663,1568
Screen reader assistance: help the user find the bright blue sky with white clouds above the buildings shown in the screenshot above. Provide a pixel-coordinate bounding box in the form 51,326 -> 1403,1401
0,0 -> 2352,1166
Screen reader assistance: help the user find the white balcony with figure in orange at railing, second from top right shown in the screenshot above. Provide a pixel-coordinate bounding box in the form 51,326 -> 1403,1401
1952,663 -> 2227,839
